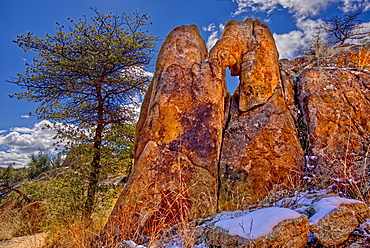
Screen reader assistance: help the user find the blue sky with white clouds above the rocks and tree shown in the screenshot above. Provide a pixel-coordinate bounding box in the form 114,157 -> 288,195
0,0 -> 370,166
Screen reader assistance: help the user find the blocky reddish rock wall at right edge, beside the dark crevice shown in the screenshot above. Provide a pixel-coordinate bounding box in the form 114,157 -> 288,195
298,67 -> 370,179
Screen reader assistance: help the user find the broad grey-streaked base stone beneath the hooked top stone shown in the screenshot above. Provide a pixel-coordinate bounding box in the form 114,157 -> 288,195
219,84 -> 304,210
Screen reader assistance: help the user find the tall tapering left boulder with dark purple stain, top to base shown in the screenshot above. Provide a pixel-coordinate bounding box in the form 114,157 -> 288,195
101,25 -> 228,243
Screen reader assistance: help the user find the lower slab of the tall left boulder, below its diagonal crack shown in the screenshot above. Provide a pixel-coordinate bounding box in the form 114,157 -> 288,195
103,141 -> 217,245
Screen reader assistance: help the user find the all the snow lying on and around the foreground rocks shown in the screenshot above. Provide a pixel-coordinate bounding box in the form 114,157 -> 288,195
117,190 -> 370,248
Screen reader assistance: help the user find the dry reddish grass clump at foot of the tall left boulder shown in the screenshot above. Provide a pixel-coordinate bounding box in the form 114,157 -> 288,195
121,163 -> 216,248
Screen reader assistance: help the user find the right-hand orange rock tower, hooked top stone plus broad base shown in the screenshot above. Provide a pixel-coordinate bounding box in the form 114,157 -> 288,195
216,19 -> 304,210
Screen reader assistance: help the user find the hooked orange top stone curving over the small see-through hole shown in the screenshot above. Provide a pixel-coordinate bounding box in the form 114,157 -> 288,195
220,18 -> 280,112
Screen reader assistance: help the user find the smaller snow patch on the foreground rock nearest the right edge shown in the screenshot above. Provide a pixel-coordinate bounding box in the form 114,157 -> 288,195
308,197 -> 362,224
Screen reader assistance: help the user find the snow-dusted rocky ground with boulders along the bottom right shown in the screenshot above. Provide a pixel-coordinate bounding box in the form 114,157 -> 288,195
119,190 -> 370,248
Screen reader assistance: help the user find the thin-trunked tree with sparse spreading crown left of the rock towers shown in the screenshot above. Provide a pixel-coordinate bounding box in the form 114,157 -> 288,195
10,9 -> 155,219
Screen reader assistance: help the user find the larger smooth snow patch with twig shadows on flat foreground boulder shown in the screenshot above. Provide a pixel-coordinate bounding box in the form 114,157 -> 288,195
215,207 -> 301,239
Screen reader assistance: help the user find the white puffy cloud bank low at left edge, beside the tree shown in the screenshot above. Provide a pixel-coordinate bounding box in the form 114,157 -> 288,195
0,120 -> 56,167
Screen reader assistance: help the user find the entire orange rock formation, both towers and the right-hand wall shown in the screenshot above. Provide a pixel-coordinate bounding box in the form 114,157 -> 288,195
100,19 -> 370,247
